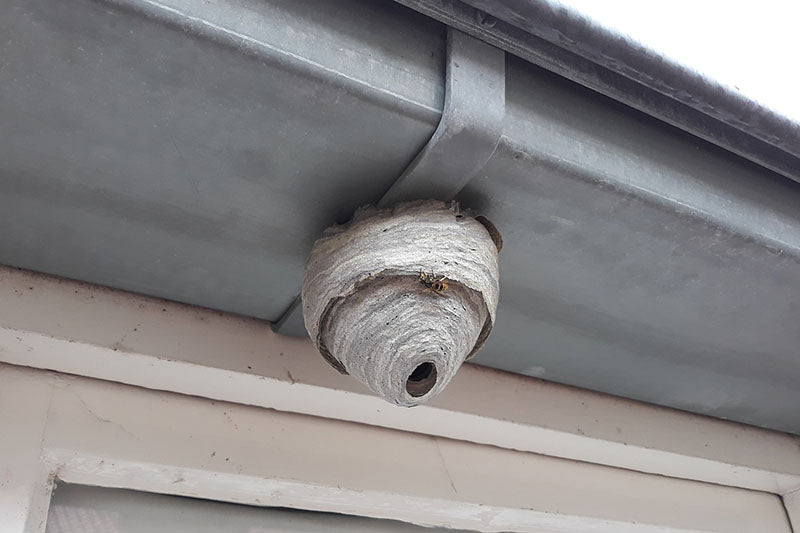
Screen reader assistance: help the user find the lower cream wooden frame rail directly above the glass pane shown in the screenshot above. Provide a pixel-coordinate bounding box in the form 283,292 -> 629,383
0,364 -> 790,533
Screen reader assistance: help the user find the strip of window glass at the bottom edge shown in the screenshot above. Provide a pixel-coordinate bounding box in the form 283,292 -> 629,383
46,483 -> 478,533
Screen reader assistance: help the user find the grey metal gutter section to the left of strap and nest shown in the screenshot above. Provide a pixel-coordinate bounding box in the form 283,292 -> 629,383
0,0 -> 446,320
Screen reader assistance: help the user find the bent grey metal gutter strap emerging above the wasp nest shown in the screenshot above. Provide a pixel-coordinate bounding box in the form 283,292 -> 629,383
273,27 -> 506,337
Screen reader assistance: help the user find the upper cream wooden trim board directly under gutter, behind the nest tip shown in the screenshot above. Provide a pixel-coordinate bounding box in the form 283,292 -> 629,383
0,267 -> 800,494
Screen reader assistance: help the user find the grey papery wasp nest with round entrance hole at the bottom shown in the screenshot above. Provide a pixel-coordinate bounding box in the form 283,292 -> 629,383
302,200 -> 502,406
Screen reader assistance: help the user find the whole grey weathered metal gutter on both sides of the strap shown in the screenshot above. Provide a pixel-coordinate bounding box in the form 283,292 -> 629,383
0,0 -> 800,433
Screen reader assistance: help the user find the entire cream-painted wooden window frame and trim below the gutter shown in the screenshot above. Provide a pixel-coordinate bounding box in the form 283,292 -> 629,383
0,267 -> 800,533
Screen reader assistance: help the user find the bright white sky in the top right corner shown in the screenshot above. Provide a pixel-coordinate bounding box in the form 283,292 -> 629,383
553,0 -> 800,123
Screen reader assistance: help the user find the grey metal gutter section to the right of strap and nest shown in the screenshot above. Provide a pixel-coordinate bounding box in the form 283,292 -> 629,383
458,57 -> 800,433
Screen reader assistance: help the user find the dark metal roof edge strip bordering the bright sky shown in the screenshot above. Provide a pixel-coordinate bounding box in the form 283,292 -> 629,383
395,0 -> 800,182
